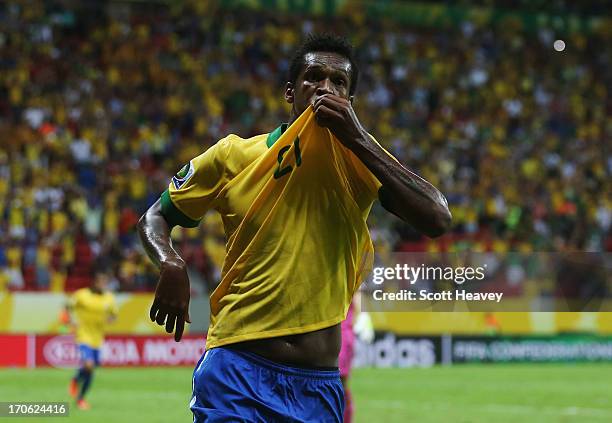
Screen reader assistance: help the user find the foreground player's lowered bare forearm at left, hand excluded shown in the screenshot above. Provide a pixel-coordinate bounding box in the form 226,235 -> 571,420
138,200 -> 185,267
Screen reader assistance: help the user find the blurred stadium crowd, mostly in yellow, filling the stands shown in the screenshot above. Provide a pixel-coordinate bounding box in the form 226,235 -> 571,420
0,2 -> 612,291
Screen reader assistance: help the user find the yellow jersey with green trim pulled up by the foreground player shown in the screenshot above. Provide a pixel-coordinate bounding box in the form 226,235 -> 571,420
161,107 -> 380,348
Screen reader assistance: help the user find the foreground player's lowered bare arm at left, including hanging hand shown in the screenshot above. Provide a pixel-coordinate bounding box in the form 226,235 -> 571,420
138,199 -> 191,342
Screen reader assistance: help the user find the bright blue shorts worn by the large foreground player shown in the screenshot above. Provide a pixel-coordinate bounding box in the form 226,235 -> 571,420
189,347 -> 344,423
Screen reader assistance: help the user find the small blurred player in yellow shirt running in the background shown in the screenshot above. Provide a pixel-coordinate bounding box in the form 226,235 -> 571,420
66,272 -> 117,410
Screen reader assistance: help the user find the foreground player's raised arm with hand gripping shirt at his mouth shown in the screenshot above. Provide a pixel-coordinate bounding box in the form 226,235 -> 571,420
313,93 -> 451,237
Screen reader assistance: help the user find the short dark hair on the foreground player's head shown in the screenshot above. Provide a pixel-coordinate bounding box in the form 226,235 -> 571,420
289,33 -> 359,95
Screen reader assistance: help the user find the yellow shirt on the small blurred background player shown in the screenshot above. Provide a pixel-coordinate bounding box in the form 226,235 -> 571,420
69,288 -> 117,349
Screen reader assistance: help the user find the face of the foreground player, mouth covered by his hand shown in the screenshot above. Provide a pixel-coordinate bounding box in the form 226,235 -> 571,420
285,52 -> 352,117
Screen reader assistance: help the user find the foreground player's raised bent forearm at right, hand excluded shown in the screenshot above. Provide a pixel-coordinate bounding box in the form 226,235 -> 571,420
352,133 -> 451,237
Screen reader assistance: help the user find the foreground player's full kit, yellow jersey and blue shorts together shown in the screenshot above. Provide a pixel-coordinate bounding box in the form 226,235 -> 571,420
161,107 -> 394,422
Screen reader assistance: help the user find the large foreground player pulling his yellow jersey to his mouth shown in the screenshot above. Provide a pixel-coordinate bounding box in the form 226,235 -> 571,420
138,35 -> 451,422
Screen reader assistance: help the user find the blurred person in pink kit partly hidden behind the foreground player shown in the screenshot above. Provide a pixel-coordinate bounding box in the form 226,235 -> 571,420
338,291 -> 374,423
